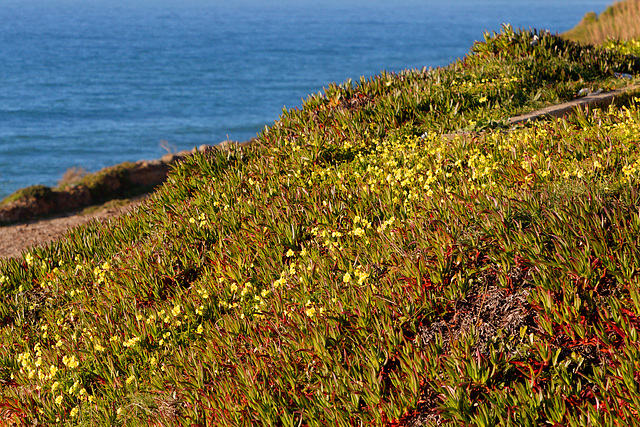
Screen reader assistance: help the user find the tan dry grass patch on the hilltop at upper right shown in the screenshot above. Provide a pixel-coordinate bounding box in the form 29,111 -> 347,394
563,0 -> 640,44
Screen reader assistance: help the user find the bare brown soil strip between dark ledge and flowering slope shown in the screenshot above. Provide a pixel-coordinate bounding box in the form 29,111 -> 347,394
0,200 -> 141,259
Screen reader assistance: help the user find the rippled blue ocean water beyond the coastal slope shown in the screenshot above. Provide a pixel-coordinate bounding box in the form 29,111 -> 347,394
0,0 -> 610,198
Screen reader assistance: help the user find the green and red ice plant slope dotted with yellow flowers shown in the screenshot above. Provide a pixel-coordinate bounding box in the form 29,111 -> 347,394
5,27 -> 640,426
